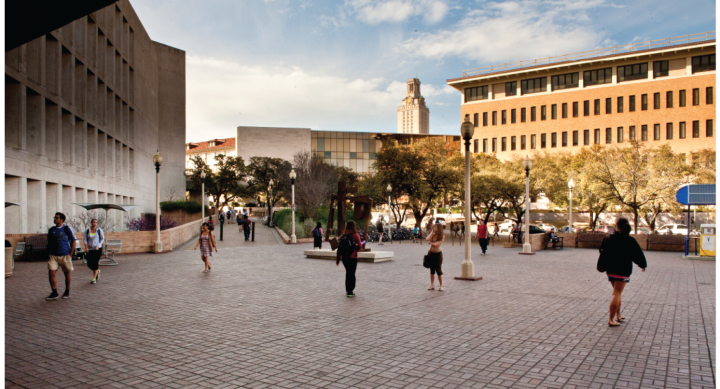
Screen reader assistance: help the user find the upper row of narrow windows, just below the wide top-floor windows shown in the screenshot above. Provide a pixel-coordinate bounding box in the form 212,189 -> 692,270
473,86 -> 715,127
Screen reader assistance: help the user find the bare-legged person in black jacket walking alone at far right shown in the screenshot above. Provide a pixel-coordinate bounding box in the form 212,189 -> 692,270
598,219 -> 647,327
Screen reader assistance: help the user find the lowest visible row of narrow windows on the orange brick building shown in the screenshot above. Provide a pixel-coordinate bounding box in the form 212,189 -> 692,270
473,119 -> 715,154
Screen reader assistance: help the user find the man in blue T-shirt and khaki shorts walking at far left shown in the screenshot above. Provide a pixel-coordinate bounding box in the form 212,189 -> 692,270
46,212 -> 77,300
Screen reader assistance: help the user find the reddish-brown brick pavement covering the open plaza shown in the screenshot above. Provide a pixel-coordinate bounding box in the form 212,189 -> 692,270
4,244 -> 717,389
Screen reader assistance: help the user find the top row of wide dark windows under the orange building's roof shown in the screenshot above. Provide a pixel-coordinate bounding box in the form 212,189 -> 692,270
465,54 -> 717,103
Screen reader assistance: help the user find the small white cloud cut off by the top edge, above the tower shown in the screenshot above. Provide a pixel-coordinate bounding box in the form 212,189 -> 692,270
345,0 -> 449,25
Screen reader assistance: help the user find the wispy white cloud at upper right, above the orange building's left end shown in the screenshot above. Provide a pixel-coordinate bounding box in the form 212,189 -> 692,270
399,0 -> 615,63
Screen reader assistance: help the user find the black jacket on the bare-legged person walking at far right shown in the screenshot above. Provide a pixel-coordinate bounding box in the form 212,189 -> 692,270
600,232 -> 647,277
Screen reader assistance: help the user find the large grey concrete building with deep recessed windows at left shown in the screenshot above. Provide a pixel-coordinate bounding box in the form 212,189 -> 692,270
4,0 -> 185,233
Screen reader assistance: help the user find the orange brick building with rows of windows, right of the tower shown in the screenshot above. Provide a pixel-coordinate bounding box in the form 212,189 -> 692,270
448,32 -> 717,160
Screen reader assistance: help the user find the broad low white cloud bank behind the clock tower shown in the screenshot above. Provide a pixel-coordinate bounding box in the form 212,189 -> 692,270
187,55 -> 454,141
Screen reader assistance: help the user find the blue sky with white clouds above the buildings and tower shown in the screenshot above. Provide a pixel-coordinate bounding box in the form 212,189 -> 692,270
131,0 -> 717,142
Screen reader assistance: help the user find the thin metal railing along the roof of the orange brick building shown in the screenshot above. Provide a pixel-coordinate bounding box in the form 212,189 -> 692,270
463,30 -> 717,77
